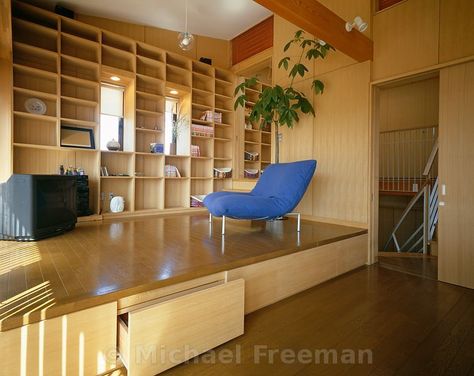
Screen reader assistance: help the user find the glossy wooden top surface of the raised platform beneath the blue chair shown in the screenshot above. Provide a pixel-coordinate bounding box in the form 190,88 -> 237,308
0,215 -> 367,331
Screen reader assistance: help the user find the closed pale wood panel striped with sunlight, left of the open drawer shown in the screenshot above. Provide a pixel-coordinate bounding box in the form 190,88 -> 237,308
0,302 -> 117,376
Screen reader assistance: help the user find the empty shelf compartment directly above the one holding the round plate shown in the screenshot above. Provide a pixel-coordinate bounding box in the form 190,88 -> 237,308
13,65 -> 57,94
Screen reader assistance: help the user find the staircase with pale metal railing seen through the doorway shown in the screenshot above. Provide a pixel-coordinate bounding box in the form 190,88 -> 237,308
380,132 -> 438,254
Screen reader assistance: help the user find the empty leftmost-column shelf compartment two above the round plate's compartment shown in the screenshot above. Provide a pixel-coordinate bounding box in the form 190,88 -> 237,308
13,42 -> 59,73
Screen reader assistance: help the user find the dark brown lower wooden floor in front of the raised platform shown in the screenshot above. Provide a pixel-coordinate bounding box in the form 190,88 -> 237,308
149,266 -> 474,376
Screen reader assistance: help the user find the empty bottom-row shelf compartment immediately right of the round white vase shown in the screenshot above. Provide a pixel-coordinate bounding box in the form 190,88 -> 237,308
135,179 -> 165,210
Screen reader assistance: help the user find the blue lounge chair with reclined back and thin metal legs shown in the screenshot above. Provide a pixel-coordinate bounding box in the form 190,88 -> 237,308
204,160 -> 316,235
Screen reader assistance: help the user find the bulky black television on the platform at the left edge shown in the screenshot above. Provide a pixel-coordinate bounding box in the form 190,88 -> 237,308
0,174 -> 77,241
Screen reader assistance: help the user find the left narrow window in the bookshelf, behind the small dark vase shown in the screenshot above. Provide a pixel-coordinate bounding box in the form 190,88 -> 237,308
100,84 -> 124,150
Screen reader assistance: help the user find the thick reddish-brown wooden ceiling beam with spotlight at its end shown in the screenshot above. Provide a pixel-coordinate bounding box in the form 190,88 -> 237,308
254,0 -> 374,62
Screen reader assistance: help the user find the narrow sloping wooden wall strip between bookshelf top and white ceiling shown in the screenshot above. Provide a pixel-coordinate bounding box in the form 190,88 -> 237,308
77,14 -> 230,68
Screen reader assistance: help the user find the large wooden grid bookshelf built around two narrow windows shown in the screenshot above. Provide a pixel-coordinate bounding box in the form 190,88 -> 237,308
11,2 -> 241,217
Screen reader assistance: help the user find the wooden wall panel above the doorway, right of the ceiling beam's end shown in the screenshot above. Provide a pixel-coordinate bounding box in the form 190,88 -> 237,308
372,0 -> 439,80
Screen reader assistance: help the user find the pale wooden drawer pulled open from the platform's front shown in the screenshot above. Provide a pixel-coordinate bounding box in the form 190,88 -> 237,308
118,279 -> 244,376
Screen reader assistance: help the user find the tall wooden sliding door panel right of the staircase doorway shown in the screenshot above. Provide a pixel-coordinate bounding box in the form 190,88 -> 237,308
438,62 -> 474,288
